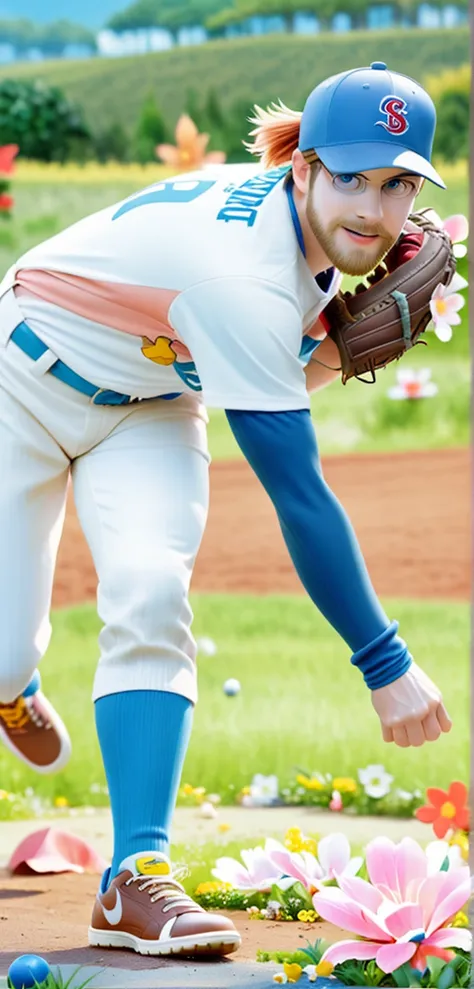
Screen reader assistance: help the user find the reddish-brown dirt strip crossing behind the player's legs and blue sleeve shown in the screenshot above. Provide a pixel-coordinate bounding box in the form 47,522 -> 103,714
53,448 -> 471,607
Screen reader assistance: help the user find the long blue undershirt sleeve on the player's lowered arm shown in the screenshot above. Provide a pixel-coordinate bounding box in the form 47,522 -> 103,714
226,409 -> 412,690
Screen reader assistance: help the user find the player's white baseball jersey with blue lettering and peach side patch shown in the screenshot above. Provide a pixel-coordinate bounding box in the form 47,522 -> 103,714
0,165 -> 341,411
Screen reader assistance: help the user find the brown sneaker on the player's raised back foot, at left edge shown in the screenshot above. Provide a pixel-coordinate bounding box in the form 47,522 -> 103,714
0,690 -> 71,773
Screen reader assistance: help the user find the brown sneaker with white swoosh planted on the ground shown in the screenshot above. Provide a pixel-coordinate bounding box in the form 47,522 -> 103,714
89,852 -> 241,957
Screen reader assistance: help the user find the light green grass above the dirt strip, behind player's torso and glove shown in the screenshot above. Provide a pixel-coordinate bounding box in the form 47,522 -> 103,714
7,162 -> 470,460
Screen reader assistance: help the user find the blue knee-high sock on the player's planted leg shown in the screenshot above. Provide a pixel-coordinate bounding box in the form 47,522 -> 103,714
95,690 -> 194,879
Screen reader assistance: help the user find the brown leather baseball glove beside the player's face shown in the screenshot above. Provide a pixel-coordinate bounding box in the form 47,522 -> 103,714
323,208 -> 456,385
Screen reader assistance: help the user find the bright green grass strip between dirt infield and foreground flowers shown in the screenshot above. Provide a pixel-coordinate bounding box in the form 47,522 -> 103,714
0,595 -> 469,805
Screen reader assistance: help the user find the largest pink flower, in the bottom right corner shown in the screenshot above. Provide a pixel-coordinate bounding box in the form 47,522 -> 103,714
313,838 -> 472,972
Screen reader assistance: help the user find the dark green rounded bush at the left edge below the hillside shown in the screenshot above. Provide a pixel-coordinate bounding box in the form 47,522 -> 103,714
0,79 -> 90,162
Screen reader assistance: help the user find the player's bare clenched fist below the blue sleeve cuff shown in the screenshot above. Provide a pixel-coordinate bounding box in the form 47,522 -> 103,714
371,663 -> 453,748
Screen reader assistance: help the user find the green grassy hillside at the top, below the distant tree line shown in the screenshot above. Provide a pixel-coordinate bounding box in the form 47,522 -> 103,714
0,25 -> 469,137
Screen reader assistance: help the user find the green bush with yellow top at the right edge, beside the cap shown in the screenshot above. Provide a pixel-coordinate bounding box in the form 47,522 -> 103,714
425,64 -> 471,161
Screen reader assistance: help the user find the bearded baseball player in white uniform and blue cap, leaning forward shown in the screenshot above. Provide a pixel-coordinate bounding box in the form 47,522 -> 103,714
0,62 -> 451,955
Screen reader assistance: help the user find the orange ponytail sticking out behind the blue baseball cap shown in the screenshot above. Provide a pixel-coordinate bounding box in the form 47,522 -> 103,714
243,100 -> 302,168
